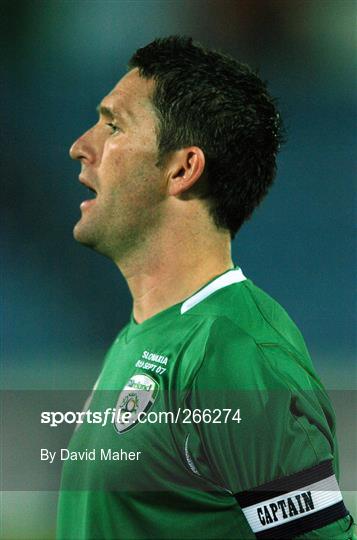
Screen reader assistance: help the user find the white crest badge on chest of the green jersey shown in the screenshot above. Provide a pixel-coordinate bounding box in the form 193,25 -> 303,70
115,373 -> 159,433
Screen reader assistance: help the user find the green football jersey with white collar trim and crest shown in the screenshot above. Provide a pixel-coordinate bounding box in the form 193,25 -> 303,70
58,268 -> 352,540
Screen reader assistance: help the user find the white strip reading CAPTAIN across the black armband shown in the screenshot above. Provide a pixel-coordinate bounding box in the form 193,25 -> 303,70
242,475 -> 342,533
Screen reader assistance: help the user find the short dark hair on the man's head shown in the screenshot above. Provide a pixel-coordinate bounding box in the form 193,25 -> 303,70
129,36 -> 283,238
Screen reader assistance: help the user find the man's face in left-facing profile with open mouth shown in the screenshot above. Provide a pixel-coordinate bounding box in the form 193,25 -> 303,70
70,69 -> 165,260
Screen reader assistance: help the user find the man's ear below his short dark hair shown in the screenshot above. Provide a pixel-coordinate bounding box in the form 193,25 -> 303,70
168,146 -> 205,196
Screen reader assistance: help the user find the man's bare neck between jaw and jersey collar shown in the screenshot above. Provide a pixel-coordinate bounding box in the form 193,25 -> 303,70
116,221 -> 233,323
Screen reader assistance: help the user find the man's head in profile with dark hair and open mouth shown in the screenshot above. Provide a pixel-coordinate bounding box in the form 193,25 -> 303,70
71,37 -> 280,259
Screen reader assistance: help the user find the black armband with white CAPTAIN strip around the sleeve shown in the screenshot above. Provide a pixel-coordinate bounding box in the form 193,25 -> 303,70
234,461 -> 348,540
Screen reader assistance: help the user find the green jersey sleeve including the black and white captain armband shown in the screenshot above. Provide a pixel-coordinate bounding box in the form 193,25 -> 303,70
186,319 -> 352,540
